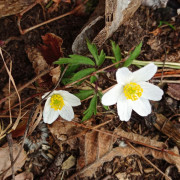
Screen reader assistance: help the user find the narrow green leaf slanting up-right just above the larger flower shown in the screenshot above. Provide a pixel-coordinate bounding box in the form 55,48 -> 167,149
123,41 -> 142,67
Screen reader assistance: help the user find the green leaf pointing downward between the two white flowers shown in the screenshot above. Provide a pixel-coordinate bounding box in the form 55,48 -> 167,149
82,94 -> 97,122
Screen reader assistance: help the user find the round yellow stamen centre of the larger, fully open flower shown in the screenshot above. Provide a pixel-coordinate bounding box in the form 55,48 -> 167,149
123,82 -> 143,101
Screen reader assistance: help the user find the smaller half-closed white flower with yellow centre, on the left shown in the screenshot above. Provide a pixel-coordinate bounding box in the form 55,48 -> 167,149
42,90 -> 81,124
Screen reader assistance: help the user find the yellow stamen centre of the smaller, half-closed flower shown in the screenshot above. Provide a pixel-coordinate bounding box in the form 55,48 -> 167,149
50,94 -> 64,111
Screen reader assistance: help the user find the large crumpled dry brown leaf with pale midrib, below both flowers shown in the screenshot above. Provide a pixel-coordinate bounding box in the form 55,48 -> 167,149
49,118 -> 180,179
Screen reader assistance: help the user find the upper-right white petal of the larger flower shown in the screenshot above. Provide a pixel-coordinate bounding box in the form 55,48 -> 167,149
132,63 -> 157,82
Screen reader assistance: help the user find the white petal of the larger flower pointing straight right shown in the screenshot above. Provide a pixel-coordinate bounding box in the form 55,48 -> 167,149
138,82 -> 164,101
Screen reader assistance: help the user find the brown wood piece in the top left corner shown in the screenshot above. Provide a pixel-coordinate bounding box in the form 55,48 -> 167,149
0,0 -> 36,18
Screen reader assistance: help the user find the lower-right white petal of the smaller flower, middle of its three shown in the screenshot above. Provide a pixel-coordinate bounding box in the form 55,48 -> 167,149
59,102 -> 74,121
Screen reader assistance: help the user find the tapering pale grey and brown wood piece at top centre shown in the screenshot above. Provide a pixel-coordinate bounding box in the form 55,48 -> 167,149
93,0 -> 142,47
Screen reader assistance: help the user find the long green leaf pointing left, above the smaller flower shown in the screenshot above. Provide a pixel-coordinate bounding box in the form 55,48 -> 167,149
54,54 -> 95,66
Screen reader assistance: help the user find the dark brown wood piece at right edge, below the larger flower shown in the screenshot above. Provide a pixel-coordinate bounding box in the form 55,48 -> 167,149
154,114 -> 180,147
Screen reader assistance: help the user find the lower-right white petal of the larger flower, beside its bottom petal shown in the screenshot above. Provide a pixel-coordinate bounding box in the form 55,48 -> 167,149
131,97 -> 151,116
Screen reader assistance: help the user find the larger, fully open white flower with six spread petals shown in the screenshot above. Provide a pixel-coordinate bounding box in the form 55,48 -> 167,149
102,63 -> 163,121
